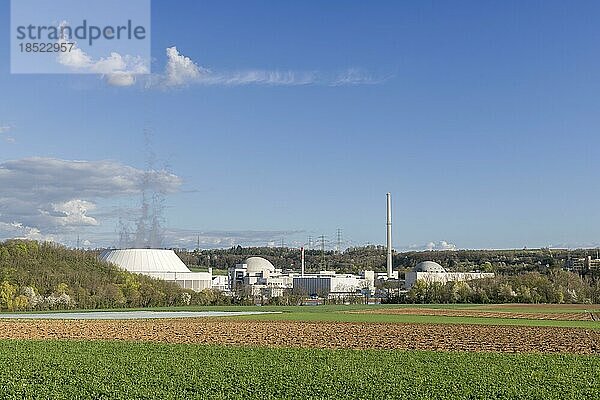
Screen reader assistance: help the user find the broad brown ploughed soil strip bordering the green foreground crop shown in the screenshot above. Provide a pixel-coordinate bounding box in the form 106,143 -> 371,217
0,318 -> 600,354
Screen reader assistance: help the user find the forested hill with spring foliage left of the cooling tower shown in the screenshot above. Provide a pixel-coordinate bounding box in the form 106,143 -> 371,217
0,240 -> 190,311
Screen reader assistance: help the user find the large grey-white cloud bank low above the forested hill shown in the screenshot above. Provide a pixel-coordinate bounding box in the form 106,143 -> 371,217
0,157 -> 182,241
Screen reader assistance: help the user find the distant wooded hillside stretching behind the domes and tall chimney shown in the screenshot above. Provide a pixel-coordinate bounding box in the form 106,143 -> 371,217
177,245 -> 600,276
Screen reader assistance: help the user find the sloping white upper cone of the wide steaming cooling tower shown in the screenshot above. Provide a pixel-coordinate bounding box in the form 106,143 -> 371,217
100,249 -> 190,273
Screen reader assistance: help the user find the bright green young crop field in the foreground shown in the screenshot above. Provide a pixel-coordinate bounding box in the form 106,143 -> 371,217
0,340 -> 600,400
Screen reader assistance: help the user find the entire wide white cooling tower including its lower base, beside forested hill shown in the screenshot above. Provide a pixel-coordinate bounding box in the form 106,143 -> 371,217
100,249 -> 212,291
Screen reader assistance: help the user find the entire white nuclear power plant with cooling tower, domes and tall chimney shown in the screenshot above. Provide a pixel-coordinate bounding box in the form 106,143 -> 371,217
100,193 -> 494,298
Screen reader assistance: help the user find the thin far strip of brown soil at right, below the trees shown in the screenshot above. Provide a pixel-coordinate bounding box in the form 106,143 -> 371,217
348,308 -> 600,321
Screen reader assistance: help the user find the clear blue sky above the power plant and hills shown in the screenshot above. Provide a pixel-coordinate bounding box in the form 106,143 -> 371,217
0,0 -> 600,249
